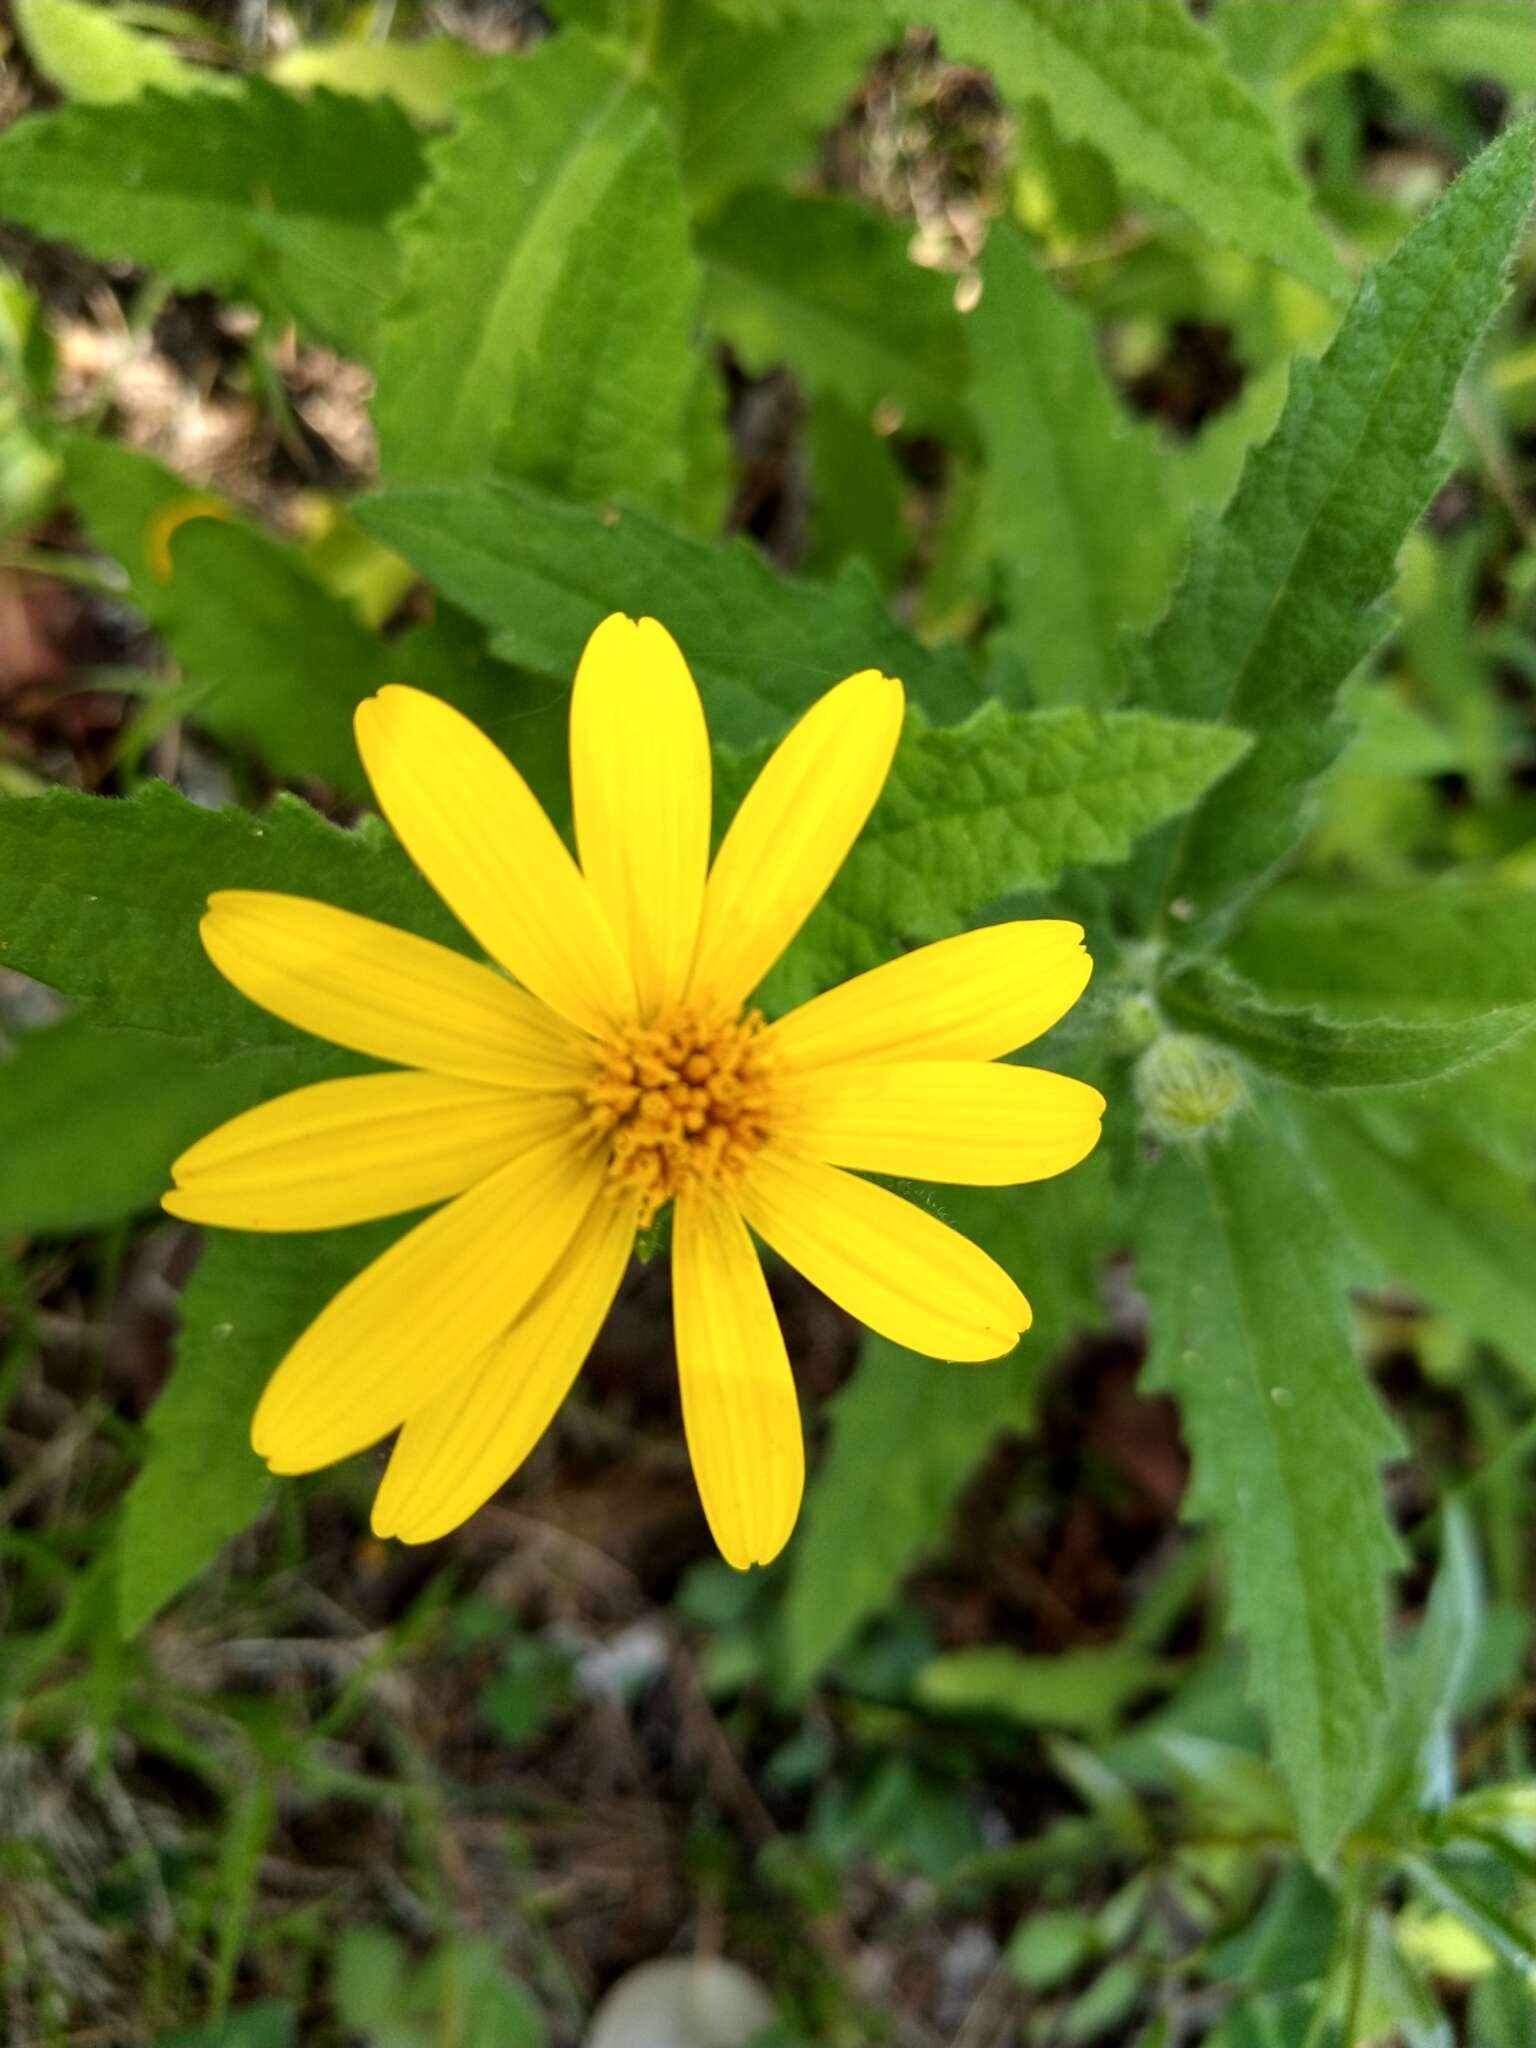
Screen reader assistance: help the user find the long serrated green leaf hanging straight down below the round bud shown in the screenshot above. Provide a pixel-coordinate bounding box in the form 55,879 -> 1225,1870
1137,1110 -> 1397,1860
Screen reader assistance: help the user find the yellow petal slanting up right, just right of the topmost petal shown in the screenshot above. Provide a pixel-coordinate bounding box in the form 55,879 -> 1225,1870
690,668 -> 903,1010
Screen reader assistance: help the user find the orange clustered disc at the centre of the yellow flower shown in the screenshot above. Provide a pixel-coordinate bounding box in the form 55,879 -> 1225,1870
586,1010 -> 782,1229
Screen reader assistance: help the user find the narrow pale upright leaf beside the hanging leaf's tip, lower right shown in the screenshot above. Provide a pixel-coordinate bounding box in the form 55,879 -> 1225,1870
1370,1499 -> 1483,1819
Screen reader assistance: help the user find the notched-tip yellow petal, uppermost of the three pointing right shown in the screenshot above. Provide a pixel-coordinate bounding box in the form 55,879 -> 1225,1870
766,918 -> 1094,1067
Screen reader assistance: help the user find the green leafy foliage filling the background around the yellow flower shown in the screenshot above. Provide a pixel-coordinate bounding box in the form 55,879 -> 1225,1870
0,0 -> 1536,2048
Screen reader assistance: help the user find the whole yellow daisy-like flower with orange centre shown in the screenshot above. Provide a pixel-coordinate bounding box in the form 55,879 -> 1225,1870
166,616 -> 1104,1569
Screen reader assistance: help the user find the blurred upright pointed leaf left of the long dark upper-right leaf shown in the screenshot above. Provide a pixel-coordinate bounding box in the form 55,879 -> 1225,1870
969,221 -> 1184,705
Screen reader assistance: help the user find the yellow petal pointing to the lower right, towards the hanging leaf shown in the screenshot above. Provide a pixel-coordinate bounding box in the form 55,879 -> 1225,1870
737,1151 -> 1030,1358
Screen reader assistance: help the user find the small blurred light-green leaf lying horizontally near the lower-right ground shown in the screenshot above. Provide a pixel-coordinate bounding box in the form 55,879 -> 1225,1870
915,1642 -> 1169,1735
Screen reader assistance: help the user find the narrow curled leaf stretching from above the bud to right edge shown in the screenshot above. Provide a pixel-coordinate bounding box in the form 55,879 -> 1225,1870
1157,963 -> 1536,1090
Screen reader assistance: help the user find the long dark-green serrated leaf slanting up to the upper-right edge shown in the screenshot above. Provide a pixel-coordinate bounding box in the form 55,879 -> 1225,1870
1137,123 -> 1536,938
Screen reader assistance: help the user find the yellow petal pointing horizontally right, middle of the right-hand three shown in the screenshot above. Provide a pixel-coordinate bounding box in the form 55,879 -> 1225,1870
774,1059 -> 1104,1188
